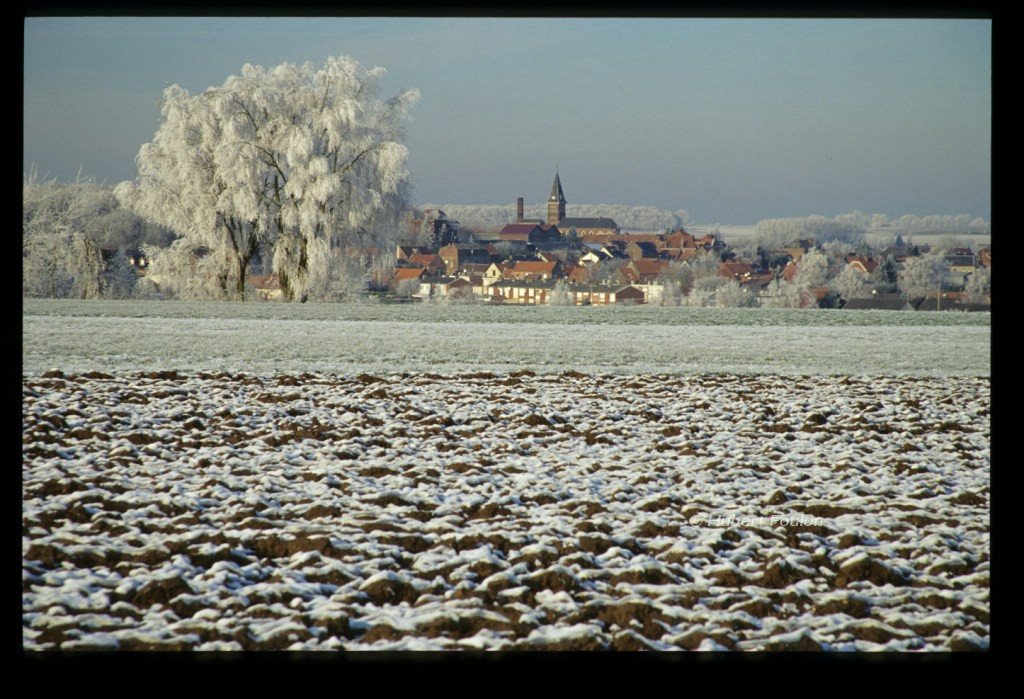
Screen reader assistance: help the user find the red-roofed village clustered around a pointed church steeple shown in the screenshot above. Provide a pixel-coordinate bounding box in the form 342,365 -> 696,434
378,174 -> 991,311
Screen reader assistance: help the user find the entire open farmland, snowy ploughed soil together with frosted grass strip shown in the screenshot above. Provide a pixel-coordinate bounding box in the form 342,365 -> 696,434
23,301 -> 990,651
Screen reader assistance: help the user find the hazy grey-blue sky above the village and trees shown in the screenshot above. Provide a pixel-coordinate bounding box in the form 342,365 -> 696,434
24,17 -> 992,225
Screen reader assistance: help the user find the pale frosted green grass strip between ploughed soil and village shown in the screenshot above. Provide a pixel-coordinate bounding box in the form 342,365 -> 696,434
23,300 -> 990,376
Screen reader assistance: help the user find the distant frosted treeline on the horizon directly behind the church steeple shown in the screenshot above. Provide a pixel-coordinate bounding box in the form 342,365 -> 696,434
420,204 -> 687,230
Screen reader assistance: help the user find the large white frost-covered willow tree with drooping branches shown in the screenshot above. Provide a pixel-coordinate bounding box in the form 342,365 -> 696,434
117,57 -> 419,301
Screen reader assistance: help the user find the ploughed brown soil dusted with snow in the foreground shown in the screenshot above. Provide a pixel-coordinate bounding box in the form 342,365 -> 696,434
23,373 -> 989,650
